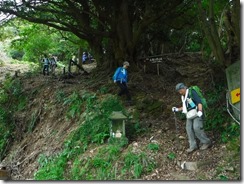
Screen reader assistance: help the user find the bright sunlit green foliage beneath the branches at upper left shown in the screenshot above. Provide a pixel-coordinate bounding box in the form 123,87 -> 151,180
0,18 -> 88,62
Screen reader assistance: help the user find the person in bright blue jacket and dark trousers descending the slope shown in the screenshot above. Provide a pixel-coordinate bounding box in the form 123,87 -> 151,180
113,61 -> 131,103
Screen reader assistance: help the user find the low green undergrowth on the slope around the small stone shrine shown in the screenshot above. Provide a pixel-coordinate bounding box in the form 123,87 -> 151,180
35,91 -> 156,180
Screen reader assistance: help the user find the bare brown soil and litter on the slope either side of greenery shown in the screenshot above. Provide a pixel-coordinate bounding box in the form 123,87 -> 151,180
0,54 -> 240,180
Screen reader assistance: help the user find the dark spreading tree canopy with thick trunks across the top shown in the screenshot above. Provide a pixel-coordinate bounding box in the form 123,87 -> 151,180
0,0 -> 240,67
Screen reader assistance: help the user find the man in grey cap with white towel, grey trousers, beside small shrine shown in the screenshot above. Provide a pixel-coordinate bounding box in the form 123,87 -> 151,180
172,83 -> 211,153
